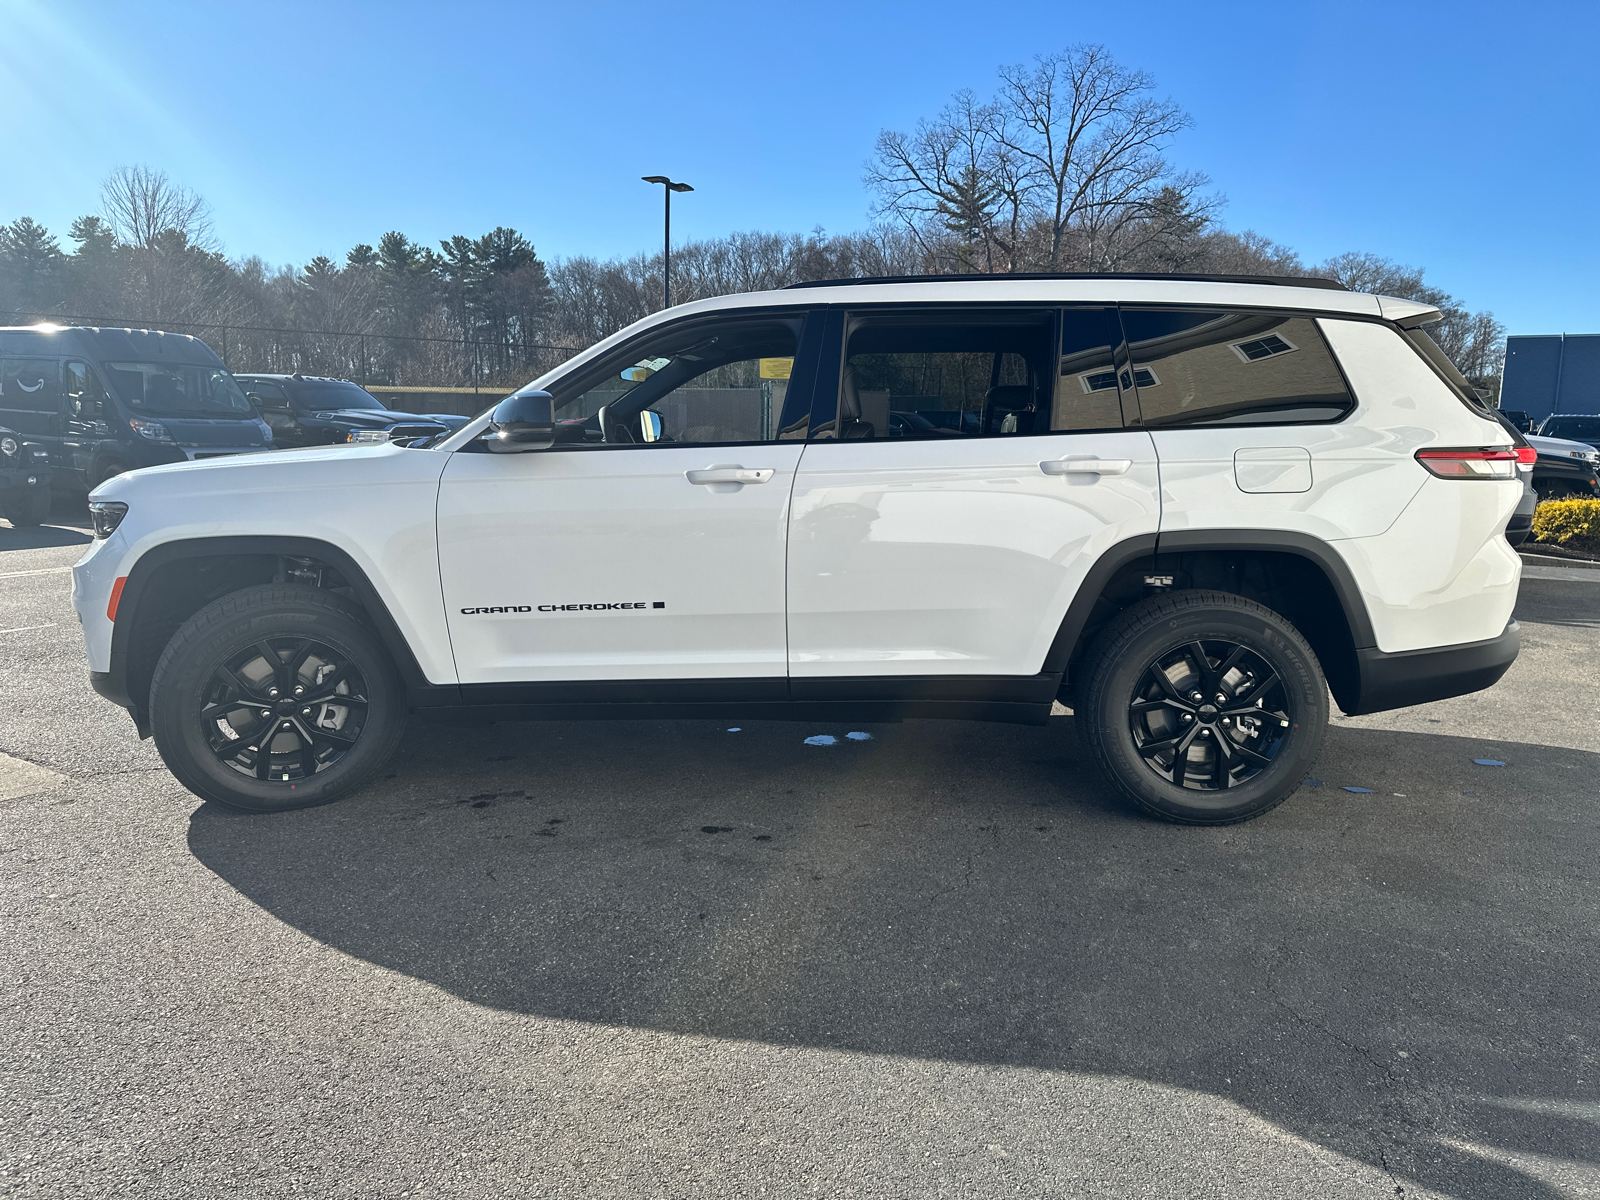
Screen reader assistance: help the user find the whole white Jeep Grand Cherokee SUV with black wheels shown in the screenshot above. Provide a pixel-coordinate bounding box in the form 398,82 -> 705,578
74,275 -> 1533,824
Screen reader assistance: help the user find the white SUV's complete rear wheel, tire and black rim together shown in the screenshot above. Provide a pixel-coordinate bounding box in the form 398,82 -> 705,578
1075,590 -> 1328,826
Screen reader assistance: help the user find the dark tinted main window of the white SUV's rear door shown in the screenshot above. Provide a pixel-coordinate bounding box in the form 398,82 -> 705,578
816,309 -> 1056,442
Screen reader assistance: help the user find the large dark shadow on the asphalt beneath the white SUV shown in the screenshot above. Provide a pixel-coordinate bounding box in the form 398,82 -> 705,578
189,718 -> 1600,1197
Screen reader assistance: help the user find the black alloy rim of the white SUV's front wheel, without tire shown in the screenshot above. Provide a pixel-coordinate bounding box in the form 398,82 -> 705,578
198,637 -> 371,782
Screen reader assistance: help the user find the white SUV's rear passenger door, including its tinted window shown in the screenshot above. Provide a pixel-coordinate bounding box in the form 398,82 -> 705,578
789,306 -> 1160,681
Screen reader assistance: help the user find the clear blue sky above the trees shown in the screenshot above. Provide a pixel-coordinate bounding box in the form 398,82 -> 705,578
0,0 -> 1600,333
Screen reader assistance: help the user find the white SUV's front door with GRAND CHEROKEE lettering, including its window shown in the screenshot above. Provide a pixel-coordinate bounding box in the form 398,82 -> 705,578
438,314 -> 810,684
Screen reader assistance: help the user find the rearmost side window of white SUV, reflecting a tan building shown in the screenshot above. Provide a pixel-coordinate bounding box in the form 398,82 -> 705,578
1122,309 -> 1355,429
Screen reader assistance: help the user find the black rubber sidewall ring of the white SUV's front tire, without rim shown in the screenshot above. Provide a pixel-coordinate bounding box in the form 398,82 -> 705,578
150,608 -> 405,813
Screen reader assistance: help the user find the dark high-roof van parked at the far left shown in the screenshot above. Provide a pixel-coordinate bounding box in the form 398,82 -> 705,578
0,325 -> 272,488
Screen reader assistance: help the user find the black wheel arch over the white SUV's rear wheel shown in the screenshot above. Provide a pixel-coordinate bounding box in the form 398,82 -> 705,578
1045,530 -> 1376,712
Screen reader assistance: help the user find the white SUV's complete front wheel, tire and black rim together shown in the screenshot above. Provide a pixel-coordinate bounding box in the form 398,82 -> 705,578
150,584 -> 406,813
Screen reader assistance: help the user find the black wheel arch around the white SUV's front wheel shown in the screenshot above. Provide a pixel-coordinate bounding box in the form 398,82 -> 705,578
106,536 -> 454,736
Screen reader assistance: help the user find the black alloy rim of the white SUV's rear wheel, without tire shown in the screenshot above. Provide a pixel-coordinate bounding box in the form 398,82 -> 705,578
1128,638 -> 1294,792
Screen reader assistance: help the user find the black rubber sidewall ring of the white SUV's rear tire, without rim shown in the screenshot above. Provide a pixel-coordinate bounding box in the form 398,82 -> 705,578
1091,608 -> 1328,824
